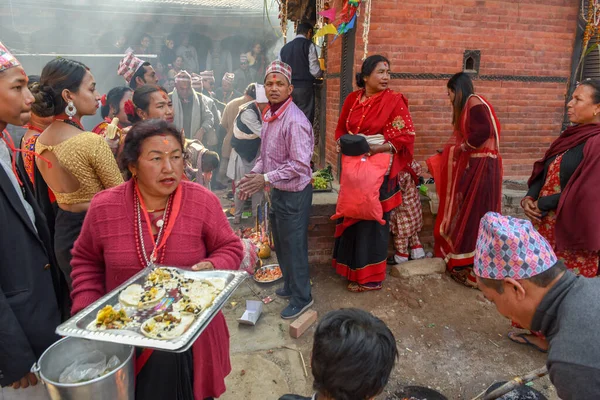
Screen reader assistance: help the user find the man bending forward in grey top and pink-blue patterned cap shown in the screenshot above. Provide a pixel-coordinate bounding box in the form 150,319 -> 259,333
473,212 -> 600,400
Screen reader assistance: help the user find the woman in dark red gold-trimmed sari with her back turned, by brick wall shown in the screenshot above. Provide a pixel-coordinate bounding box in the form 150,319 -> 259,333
434,72 -> 502,287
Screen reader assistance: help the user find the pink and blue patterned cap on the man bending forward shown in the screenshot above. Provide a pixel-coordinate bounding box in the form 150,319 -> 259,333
473,212 -> 558,280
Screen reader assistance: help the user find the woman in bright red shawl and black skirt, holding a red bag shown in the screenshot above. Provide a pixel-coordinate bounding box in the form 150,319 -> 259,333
333,55 -> 415,292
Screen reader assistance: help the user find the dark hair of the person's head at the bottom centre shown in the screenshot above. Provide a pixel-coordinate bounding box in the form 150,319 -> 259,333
311,308 -> 398,400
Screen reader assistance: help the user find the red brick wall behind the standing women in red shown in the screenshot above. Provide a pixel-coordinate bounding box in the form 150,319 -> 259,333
326,0 -> 579,179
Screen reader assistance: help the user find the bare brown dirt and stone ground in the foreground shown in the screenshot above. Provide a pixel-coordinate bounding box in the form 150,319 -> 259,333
221,189 -> 558,400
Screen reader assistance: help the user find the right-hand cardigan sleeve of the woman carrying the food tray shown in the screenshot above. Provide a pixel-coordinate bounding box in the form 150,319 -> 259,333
202,195 -> 243,270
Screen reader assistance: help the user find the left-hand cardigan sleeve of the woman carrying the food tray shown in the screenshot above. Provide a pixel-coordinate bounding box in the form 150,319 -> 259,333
71,200 -> 106,315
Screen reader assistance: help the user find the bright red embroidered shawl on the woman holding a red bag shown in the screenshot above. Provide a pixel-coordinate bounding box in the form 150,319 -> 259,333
335,89 -> 415,179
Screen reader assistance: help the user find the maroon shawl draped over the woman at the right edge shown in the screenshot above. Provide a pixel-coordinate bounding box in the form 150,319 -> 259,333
529,124 -> 600,251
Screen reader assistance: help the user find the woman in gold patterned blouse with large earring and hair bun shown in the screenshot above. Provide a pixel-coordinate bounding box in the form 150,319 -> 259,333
32,58 -> 123,288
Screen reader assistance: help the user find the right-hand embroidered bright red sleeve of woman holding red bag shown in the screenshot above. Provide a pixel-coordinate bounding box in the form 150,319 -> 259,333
383,94 -> 415,170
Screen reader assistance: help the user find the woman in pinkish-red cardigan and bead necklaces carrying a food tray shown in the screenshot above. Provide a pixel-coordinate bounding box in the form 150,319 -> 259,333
72,119 -> 242,400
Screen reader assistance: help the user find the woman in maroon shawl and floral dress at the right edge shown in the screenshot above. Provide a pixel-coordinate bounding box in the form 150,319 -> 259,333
508,79 -> 600,351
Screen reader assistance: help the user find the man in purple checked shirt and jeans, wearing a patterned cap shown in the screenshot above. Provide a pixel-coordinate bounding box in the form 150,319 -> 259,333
236,61 -> 314,319
